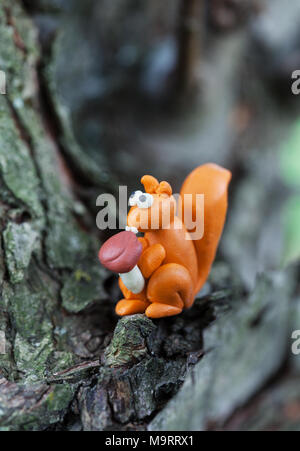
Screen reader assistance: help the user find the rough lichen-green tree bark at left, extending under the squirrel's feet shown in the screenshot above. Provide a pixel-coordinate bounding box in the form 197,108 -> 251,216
0,0 -> 206,430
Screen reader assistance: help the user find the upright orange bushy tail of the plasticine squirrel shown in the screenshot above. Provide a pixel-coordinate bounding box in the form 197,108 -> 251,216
180,163 -> 231,294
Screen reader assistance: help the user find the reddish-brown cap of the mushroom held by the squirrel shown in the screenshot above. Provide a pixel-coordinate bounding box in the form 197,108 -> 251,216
99,232 -> 143,274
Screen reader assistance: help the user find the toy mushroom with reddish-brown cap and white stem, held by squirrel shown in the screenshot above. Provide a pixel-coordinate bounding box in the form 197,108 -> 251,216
99,231 -> 145,294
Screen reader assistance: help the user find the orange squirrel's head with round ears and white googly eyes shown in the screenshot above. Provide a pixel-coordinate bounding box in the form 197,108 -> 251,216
127,175 -> 176,232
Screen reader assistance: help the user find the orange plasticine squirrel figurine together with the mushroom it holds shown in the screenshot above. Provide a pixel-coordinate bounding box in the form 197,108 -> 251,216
99,163 -> 231,318
